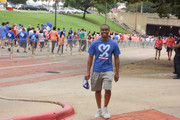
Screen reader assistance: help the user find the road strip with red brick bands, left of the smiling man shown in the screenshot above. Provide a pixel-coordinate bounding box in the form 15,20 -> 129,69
0,58 -> 86,87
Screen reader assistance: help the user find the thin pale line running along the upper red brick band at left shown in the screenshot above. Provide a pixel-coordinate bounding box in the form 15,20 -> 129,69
0,61 -> 66,70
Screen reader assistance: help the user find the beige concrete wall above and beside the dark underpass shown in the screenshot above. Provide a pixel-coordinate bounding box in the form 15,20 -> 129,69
108,12 -> 180,34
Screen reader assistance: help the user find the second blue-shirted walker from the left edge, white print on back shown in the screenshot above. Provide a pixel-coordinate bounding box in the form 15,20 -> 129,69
6,27 -> 15,52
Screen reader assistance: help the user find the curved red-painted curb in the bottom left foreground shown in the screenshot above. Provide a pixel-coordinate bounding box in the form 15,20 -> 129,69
0,97 -> 76,120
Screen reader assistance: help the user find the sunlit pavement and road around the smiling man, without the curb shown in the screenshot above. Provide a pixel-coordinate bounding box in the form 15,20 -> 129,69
0,48 -> 180,120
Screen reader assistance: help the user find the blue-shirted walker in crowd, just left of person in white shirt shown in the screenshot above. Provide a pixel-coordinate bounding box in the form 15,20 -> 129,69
29,31 -> 39,51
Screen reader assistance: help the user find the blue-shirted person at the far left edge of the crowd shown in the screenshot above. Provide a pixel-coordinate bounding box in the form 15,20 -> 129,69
0,22 -> 7,49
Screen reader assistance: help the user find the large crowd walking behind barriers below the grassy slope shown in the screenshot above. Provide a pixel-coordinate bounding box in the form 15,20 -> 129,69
0,22 -> 160,53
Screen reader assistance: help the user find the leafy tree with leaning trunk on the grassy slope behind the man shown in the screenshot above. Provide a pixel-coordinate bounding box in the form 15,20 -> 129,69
64,0 -> 93,19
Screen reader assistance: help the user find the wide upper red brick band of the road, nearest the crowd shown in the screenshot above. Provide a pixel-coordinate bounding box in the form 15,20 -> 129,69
0,61 -> 85,78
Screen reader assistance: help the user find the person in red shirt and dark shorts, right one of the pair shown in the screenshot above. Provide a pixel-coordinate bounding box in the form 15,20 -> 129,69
166,33 -> 175,60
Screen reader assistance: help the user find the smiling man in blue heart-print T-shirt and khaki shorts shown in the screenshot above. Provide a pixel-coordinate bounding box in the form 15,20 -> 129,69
85,25 -> 120,119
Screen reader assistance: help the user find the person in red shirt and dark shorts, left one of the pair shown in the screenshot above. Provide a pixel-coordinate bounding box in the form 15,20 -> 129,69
154,36 -> 163,60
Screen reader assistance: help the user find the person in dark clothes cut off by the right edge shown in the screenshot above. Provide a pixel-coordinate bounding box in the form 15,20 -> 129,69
173,29 -> 180,79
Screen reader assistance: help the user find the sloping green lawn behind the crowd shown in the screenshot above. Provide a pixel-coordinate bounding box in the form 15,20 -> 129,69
0,11 -> 127,33
